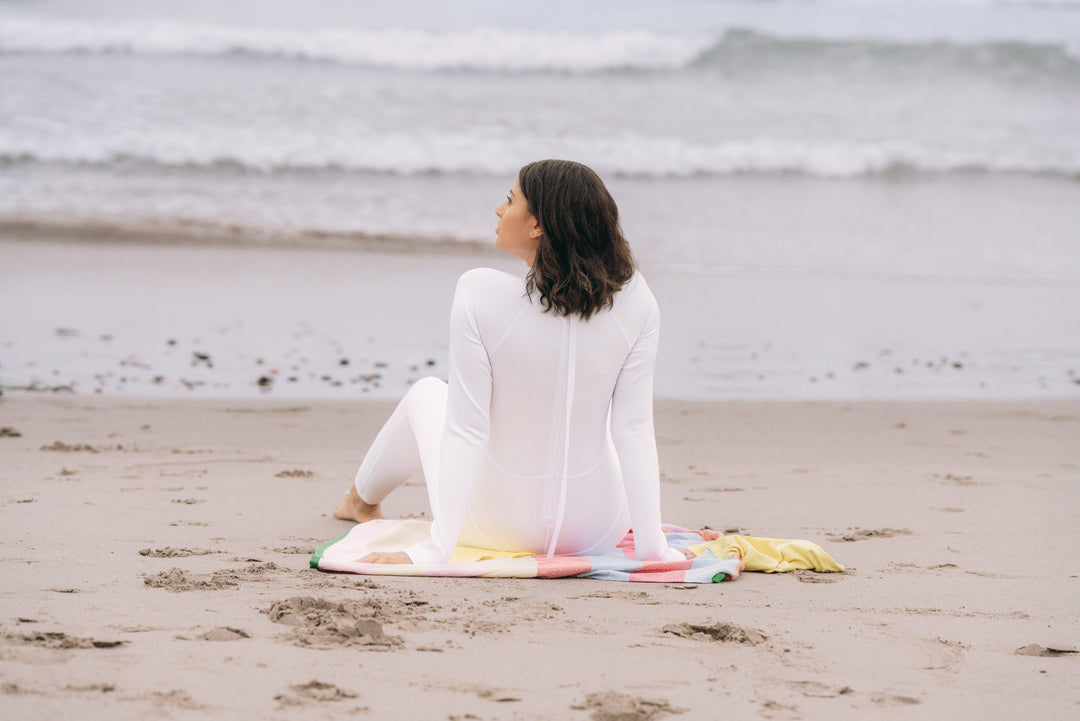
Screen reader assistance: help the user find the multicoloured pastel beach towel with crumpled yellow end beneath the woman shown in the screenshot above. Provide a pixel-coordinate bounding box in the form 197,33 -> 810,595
311,519 -> 843,583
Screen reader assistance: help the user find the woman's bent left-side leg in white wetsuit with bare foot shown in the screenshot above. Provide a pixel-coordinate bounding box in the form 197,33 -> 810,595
334,378 -> 446,522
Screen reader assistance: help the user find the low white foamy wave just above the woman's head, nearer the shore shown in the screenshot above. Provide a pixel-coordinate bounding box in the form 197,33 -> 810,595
0,133 -> 1080,179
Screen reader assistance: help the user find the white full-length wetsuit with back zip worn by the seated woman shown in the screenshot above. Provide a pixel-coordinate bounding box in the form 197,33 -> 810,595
356,269 -> 683,563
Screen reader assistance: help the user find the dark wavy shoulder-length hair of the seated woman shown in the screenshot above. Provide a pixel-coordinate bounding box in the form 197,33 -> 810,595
517,160 -> 635,319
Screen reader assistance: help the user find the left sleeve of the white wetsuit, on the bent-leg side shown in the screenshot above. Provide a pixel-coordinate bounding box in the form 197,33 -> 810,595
406,271 -> 491,563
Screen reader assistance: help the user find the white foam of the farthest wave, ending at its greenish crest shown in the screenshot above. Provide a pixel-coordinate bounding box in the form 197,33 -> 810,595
0,17 -> 712,71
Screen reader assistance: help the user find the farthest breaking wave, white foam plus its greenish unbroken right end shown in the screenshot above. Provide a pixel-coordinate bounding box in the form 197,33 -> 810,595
0,17 -> 1080,77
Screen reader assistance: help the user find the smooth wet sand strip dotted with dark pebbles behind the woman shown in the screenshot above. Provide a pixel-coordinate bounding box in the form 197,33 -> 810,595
0,240 -> 1080,400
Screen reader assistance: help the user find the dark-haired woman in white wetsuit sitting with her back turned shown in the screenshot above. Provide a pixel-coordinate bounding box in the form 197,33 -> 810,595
334,160 -> 684,563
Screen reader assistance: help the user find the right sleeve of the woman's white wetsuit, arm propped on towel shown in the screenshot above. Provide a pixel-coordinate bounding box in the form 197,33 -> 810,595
611,298 -> 684,561
